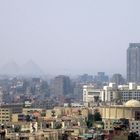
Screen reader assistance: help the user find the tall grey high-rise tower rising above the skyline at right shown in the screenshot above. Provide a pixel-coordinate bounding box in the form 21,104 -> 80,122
127,43 -> 140,83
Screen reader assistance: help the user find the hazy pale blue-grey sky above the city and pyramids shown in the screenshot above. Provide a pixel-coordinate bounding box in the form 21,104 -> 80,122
0,0 -> 140,74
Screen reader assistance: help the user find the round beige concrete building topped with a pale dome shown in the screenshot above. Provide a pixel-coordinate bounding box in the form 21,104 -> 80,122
101,100 -> 140,129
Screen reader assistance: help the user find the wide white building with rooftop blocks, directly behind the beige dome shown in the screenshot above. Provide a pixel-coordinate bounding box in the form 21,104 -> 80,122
101,83 -> 140,103
